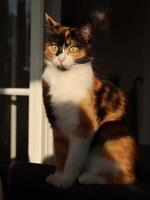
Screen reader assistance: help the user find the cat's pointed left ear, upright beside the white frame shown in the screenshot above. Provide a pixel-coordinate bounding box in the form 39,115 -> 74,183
45,13 -> 61,31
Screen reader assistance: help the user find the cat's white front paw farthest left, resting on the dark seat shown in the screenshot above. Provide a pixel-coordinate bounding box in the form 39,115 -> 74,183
46,174 -> 74,188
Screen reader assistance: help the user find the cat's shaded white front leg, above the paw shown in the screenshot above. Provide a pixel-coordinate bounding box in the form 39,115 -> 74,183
61,135 -> 92,188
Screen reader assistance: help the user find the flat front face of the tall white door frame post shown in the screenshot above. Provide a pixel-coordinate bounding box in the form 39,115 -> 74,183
28,0 -> 44,163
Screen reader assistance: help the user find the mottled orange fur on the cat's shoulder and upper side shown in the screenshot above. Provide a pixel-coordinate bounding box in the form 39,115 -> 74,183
75,74 -> 126,137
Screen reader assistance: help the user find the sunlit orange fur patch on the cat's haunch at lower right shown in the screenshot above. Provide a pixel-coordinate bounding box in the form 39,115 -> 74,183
103,136 -> 137,184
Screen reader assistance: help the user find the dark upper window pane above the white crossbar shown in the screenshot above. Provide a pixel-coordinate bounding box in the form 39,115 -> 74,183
0,0 -> 31,87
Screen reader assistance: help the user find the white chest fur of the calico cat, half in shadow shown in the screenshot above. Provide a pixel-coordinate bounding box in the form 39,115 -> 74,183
42,64 -> 93,136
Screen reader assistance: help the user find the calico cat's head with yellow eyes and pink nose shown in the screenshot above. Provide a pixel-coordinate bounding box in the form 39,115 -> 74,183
44,14 -> 92,71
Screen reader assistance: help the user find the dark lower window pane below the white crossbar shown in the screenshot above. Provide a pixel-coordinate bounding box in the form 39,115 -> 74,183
0,96 -> 28,163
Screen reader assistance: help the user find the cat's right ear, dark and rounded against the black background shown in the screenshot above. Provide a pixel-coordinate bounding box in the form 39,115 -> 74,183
77,23 -> 92,43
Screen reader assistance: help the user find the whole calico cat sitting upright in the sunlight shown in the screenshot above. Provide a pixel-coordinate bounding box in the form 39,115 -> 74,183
42,14 -> 136,188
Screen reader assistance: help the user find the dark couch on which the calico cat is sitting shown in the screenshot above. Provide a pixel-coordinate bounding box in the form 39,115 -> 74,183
8,148 -> 150,200
